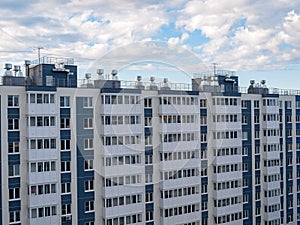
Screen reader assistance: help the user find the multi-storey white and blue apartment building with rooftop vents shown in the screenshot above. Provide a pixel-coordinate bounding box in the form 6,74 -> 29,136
0,58 -> 300,225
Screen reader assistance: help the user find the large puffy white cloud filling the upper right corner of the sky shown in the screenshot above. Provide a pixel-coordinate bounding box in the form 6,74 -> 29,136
176,0 -> 300,69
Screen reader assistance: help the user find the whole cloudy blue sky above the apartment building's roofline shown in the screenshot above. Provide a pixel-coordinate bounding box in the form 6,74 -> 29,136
0,0 -> 300,89
